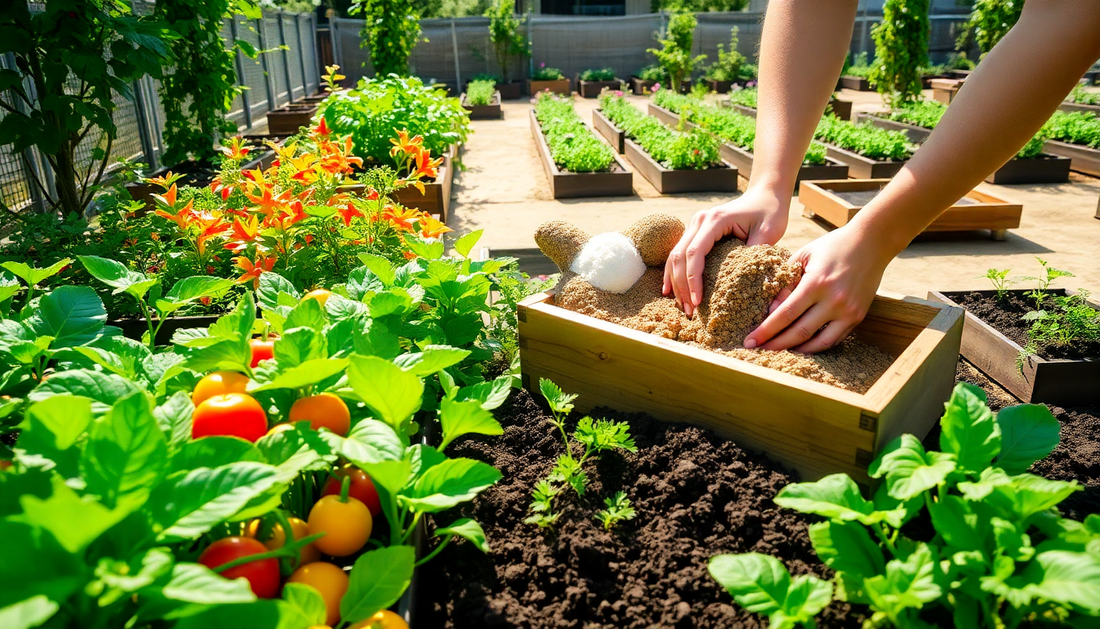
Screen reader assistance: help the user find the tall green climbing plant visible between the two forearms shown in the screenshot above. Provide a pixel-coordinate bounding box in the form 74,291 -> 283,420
867,0 -> 931,106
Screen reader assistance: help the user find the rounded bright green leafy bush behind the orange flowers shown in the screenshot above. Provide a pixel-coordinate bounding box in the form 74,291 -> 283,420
319,77 -> 470,167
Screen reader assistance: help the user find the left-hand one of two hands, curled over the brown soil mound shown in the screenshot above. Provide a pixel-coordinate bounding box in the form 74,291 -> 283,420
662,185 -> 791,317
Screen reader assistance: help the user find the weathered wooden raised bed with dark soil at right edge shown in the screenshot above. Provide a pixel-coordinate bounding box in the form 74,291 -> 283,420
928,289 -> 1100,406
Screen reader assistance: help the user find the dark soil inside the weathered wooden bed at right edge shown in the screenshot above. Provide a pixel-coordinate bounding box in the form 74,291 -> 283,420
950,290 -> 1100,360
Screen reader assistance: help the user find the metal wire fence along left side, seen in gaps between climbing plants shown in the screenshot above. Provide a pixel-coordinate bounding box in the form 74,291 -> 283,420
0,10 -> 321,209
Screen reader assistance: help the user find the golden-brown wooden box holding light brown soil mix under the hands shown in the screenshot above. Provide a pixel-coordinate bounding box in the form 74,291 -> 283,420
517,294 -> 963,483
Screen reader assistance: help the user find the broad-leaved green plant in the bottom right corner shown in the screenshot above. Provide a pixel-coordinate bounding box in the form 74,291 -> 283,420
711,383 -> 1100,628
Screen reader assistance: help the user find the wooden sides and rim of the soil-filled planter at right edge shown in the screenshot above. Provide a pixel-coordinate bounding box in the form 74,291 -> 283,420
928,290 -> 1100,406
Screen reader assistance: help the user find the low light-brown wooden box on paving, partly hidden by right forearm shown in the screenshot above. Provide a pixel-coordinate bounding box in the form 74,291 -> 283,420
799,179 -> 1023,241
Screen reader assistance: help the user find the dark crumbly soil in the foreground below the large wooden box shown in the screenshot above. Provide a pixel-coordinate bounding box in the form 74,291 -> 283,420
417,390 -> 862,629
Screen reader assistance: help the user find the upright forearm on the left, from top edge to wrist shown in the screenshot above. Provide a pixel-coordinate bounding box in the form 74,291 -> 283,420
749,0 -> 858,202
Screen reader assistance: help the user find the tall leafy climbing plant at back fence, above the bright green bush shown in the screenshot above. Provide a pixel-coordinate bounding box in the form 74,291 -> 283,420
350,0 -> 420,77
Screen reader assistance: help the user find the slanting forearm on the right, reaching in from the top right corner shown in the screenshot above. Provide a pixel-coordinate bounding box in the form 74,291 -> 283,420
849,0 -> 1100,261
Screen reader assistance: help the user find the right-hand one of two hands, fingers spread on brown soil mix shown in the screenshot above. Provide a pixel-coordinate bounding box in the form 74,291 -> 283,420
745,223 -> 893,354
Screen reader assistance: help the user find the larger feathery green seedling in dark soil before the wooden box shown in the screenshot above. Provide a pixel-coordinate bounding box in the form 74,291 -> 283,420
524,378 -> 637,528
